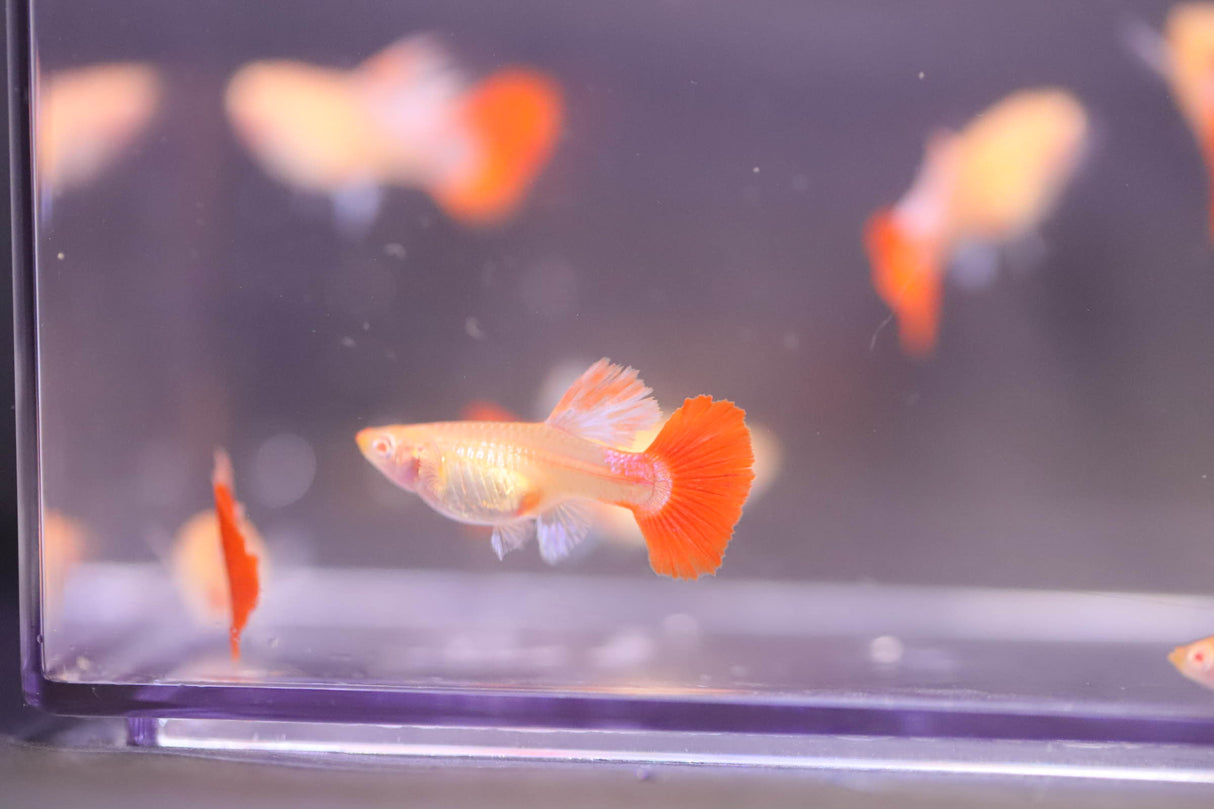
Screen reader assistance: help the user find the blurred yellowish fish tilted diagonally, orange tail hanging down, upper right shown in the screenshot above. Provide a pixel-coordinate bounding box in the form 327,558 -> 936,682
864,89 -> 1088,357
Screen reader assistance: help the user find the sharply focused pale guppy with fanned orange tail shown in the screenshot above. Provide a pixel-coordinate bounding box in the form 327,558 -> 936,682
357,358 -> 754,578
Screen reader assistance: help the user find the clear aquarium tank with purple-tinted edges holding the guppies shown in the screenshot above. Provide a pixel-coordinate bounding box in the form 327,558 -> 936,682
10,0 -> 1214,757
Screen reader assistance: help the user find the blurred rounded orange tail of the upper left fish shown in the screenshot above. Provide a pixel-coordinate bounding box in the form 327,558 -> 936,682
433,68 -> 562,225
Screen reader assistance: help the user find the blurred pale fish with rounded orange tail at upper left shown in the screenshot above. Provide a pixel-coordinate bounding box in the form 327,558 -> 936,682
225,35 -> 562,232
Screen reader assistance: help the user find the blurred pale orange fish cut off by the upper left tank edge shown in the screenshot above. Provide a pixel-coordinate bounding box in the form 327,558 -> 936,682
35,62 -> 161,215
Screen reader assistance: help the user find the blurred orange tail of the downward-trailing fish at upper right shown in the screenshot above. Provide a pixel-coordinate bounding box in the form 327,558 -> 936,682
864,208 -> 943,357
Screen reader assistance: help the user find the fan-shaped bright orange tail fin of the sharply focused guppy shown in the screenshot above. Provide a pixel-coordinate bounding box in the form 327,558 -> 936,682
629,396 -> 754,578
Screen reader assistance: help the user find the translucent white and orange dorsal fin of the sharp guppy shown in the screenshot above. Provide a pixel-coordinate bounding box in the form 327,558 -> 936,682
548,357 -> 662,448
